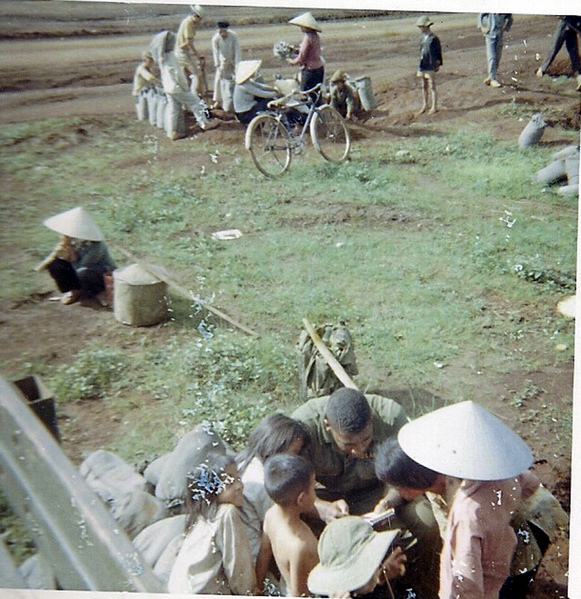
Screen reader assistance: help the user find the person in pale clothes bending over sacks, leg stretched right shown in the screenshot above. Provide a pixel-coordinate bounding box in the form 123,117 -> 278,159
150,31 -> 220,139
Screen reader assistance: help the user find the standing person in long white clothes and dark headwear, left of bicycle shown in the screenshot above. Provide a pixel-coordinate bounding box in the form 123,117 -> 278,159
212,21 -> 240,112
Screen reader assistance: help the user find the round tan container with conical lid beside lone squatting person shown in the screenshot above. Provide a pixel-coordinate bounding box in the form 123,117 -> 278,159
113,264 -> 167,327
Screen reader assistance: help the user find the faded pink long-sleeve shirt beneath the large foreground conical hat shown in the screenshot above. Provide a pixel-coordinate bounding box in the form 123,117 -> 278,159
440,473 -> 539,599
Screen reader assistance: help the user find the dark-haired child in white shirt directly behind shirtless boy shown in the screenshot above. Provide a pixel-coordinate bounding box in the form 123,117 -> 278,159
236,413 -> 309,560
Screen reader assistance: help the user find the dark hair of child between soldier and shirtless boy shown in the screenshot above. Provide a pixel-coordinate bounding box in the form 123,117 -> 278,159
236,413 -> 310,470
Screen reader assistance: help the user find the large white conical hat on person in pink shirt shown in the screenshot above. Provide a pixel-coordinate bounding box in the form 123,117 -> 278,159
398,401 -> 533,480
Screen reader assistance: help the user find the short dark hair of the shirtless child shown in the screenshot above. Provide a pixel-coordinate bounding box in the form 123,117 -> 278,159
264,453 -> 315,506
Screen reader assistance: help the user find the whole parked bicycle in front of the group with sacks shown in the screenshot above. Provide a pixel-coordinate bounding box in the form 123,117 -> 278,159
244,83 -> 351,177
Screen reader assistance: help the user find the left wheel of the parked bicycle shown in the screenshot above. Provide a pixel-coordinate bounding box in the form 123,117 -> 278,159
245,114 -> 291,177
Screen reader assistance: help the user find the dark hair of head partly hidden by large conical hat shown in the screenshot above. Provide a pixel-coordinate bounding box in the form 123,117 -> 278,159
375,437 -> 438,491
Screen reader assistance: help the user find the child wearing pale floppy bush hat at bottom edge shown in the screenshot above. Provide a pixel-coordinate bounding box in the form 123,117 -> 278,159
308,516 -> 406,599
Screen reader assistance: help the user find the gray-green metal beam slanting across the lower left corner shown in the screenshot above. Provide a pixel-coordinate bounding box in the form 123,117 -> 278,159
0,377 -> 164,592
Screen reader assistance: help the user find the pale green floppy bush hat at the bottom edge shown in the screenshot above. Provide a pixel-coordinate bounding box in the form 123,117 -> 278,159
307,516 -> 400,595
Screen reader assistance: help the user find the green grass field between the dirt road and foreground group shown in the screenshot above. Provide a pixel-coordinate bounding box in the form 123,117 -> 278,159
0,119 -> 577,457
